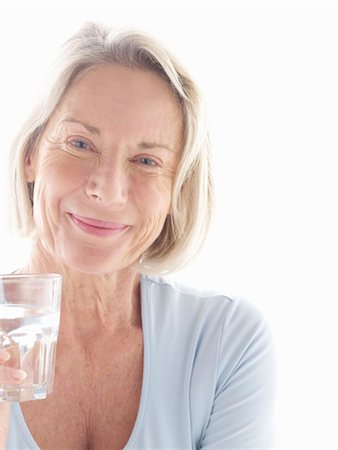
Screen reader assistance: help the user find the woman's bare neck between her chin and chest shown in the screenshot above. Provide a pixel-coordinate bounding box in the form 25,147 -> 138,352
20,239 -> 141,341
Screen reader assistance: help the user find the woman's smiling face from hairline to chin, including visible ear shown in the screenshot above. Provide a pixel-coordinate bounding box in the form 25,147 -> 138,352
26,65 -> 183,274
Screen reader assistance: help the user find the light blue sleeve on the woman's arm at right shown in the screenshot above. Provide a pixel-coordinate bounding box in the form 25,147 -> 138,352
199,300 -> 276,450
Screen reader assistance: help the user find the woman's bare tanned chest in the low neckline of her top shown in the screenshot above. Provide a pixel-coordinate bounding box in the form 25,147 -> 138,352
22,336 -> 143,450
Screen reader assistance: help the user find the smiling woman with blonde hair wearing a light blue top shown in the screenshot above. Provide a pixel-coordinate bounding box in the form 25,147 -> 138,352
0,24 -> 274,450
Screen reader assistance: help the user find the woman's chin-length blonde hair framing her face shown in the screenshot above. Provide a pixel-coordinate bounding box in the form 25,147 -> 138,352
11,22 -> 214,275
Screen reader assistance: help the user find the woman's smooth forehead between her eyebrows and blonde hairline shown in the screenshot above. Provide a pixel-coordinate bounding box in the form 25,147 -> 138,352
52,64 -> 183,142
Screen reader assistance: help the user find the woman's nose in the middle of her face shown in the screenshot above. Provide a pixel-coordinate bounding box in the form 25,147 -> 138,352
85,155 -> 128,205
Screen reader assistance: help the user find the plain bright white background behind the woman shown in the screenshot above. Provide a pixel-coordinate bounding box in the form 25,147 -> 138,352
0,1 -> 338,450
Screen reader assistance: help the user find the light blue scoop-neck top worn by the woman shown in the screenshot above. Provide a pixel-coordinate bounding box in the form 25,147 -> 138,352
6,276 -> 276,450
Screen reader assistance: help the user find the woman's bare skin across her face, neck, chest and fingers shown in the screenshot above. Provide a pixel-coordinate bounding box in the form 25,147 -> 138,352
0,65 -> 183,450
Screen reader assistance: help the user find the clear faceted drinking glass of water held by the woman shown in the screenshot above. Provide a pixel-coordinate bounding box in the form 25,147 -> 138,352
0,273 -> 62,402
